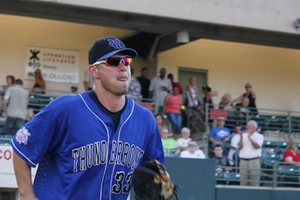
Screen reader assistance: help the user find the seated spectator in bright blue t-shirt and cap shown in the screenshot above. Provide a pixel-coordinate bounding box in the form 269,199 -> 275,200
209,117 -> 230,149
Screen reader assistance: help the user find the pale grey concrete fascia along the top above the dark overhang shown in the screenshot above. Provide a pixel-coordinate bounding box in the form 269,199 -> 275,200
41,0 -> 300,34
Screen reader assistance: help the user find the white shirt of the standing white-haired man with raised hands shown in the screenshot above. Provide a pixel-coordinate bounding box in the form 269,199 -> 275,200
239,132 -> 264,159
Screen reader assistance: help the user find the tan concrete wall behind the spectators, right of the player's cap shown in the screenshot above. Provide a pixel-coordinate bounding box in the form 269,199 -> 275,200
157,39 -> 300,111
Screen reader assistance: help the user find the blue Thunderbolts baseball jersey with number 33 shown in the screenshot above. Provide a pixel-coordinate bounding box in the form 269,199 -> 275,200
11,92 -> 164,200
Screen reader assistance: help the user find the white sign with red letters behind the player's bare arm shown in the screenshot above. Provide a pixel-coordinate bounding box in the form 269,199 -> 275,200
0,145 -> 37,188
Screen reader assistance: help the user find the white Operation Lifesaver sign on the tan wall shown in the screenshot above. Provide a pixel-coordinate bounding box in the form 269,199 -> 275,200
25,46 -> 79,84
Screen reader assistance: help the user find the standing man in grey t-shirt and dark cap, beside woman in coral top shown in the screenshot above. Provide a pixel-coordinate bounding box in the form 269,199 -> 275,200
149,68 -> 172,113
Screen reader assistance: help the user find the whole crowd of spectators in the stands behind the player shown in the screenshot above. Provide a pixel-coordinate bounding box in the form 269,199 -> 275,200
1,68 -> 300,188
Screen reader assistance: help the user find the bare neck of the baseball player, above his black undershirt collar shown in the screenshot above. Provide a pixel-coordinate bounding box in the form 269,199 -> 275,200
94,88 -> 125,112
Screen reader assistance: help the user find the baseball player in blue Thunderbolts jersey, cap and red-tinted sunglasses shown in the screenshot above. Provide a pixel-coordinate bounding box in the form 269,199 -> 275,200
11,37 -> 164,200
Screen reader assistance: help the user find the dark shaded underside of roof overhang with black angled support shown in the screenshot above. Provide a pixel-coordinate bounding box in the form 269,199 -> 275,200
0,0 -> 300,59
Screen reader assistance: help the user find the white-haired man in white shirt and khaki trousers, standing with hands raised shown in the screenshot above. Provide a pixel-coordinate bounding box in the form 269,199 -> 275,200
238,120 -> 264,186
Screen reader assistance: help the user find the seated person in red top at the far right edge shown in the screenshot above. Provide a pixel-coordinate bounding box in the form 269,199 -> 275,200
283,139 -> 300,166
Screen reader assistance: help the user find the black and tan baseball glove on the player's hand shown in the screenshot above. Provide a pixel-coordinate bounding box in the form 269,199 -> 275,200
132,159 -> 178,200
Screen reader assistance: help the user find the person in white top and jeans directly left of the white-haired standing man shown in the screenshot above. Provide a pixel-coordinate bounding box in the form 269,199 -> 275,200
228,122 -> 246,165
